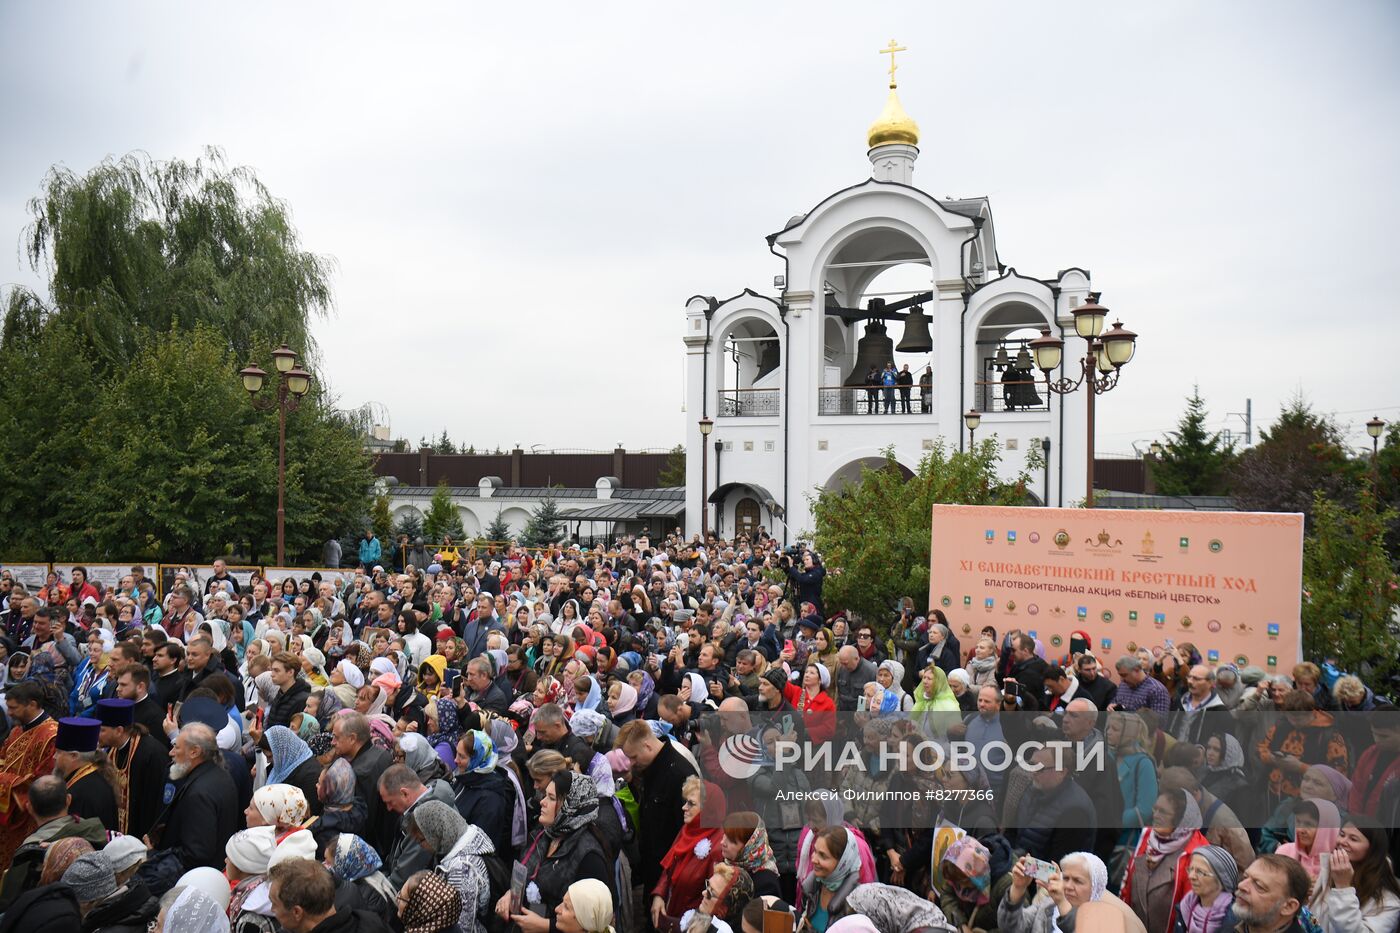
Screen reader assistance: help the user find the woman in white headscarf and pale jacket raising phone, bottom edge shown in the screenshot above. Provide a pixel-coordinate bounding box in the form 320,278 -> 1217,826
997,852 -> 1147,933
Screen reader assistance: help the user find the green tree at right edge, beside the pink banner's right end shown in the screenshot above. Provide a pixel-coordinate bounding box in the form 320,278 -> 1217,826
1302,482 -> 1400,682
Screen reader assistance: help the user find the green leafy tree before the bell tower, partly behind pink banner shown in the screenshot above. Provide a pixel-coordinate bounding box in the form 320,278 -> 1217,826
812,440 -> 1030,625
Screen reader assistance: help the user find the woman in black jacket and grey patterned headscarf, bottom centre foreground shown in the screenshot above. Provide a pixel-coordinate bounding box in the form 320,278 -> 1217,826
496,769 -> 615,933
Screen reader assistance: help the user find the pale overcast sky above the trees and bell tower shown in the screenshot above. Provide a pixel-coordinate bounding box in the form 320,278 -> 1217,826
0,0 -> 1400,452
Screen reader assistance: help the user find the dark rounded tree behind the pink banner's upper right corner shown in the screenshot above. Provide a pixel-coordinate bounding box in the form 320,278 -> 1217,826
1229,396 -> 1365,517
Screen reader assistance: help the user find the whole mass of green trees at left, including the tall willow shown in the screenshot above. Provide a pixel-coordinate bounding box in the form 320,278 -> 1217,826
0,150 -> 372,560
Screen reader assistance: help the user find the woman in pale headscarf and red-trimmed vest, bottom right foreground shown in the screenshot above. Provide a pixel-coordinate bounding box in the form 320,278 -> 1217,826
1121,789 -> 1210,933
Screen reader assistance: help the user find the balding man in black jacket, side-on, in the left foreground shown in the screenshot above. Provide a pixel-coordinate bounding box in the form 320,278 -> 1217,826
150,723 -> 239,879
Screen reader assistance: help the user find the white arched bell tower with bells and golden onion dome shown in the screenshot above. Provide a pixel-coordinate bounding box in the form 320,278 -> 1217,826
683,50 -> 1092,542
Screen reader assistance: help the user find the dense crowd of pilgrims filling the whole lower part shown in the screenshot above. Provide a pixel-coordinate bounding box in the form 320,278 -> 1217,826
0,532 -> 1400,933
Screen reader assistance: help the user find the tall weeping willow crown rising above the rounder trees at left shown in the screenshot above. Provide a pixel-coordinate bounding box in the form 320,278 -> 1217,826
0,148 -> 332,373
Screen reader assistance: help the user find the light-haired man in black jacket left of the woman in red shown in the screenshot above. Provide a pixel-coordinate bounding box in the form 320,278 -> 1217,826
617,720 -> 696,891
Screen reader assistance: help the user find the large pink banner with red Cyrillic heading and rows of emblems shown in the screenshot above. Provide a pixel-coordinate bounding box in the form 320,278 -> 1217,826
928,506 -> 1303,672
